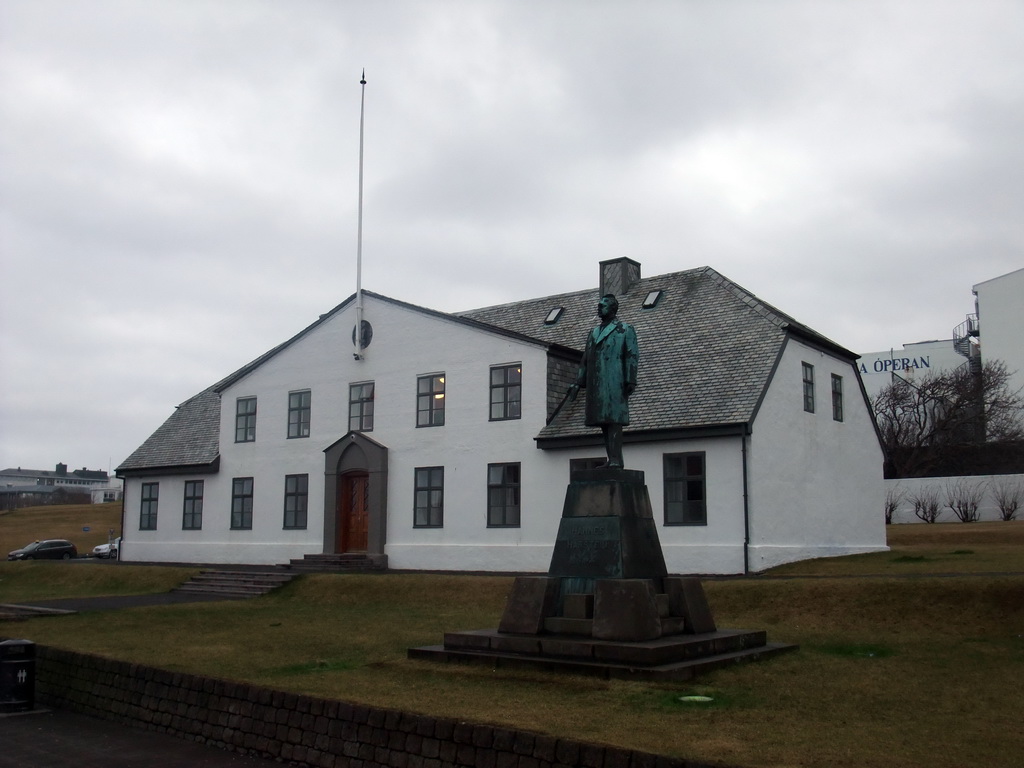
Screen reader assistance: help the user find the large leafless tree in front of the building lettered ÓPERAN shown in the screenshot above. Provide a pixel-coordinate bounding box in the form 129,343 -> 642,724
871,360 -> 1024,477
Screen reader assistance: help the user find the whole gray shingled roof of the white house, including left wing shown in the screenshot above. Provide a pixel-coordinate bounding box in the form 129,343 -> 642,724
117,267 -> 856,474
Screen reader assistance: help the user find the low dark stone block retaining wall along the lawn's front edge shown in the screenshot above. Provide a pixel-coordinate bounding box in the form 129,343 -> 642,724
36,646 -> 723,768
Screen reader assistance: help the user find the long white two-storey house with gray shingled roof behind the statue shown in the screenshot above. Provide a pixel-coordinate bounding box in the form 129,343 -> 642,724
118,259 -> 886,573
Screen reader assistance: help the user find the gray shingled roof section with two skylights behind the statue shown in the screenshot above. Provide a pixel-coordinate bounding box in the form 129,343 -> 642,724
460,267 -> 856,439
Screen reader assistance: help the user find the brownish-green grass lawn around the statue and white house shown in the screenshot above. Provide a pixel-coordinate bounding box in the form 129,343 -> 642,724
0,512 -> 1024,768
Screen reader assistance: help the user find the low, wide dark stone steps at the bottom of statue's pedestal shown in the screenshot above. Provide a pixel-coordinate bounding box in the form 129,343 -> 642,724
409,630 -> 798,680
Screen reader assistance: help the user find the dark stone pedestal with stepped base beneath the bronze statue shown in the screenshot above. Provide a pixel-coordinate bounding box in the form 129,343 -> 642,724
409,469 -> 796,679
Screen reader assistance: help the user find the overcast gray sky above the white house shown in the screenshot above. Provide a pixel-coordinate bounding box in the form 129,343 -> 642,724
0,0 -> 1024,470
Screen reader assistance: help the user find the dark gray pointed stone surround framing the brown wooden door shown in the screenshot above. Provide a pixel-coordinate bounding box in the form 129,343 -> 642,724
324,432 -> 388,559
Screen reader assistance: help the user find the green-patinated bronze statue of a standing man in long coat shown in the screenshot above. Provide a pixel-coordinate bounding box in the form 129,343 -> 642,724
569,294 -> 640,468
